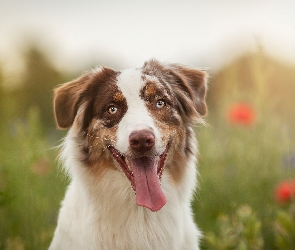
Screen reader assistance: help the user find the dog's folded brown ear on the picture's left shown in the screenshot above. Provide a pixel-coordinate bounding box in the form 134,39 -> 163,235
54,74 -> 91,129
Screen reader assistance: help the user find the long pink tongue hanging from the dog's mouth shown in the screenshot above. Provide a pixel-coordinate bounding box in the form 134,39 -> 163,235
129,157 -> 166,212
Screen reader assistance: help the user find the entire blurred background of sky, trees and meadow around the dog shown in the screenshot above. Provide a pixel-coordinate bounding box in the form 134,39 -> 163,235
0,0 -> 295,249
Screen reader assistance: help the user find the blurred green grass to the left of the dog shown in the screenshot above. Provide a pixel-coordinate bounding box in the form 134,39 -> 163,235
0,109 -> 64,249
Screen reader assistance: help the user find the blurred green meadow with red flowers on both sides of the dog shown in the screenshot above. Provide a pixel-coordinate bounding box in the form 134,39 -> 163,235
0,46 -> 295,250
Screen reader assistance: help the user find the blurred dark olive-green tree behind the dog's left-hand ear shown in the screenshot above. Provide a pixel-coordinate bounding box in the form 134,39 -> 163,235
8,44 -> 66,127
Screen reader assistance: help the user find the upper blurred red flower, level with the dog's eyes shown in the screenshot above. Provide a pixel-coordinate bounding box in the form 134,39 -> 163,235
228,103 -> 255,126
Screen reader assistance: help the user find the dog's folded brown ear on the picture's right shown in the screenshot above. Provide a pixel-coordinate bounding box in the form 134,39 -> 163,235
172,65 -> 207,116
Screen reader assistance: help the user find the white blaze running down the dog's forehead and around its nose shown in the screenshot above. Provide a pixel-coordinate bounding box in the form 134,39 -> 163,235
116,69 -> 163,153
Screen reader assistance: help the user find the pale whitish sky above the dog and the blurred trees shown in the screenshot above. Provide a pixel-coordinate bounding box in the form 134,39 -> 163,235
0,0 -> 295,70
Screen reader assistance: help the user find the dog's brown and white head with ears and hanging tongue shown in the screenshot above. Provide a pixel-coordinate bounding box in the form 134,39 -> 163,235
54,60 -> 206,211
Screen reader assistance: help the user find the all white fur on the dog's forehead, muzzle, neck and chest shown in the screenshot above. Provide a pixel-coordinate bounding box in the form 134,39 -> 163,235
49,67 -> 200,250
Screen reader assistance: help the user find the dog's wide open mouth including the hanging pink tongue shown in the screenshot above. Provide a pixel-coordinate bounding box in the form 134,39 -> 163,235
108,143 -> 170,212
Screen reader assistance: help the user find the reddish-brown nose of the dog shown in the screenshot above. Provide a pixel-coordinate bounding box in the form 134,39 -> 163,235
129,130 -> 155,153
